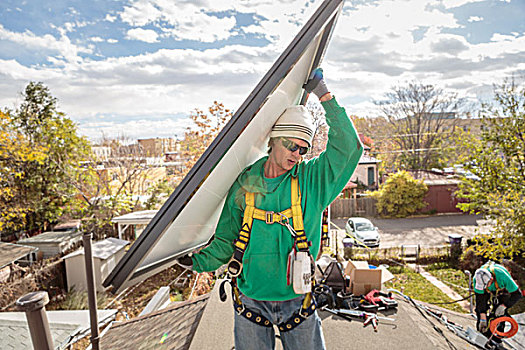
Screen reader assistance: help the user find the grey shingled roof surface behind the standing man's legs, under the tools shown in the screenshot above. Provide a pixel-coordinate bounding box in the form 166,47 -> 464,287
190,281 -> 484,350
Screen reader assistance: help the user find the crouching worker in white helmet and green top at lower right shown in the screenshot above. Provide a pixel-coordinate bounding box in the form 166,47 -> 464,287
474,261 -> 522,348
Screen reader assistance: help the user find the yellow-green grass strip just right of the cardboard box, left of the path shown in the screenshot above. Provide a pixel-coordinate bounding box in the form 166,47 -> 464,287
385,266 -> 466,313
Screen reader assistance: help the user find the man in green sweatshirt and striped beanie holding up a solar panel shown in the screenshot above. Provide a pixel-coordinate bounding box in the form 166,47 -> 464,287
179,69 -> 363,350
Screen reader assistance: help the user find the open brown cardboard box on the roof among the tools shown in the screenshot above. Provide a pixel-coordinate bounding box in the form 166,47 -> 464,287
345,260 -> 380,295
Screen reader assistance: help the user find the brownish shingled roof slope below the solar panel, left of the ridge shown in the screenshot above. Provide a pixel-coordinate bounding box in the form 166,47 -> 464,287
100,295 -> 209,350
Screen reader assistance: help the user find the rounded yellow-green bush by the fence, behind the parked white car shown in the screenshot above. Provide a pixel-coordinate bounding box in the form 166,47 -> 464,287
369,171 -> 428,218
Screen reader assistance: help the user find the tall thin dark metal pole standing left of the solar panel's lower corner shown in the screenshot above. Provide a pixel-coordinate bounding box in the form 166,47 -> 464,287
82,233 -> 100,350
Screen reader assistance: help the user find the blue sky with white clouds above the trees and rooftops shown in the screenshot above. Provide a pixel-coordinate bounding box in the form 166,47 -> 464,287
0,0 -> 525,142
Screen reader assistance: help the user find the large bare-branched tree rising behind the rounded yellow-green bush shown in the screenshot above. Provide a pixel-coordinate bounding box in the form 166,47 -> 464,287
374,83 -> 466,174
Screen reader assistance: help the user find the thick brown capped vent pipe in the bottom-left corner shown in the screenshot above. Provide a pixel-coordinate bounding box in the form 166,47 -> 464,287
16,291 -> 54,350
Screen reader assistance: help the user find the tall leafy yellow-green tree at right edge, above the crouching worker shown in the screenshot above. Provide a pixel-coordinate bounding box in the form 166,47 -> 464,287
457,81 -> 525,259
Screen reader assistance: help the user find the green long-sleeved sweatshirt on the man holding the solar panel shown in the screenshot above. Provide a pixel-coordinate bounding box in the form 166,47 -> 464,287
193,99 -> 363,301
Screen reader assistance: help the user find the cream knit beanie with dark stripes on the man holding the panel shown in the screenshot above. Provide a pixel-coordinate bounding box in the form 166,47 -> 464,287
270,106 -> 314,147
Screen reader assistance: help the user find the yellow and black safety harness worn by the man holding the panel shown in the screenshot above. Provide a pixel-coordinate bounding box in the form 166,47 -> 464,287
220,177 -> 316,332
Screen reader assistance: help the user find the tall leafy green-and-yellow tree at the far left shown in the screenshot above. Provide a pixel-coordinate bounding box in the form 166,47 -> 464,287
4,82 -> 90,231
